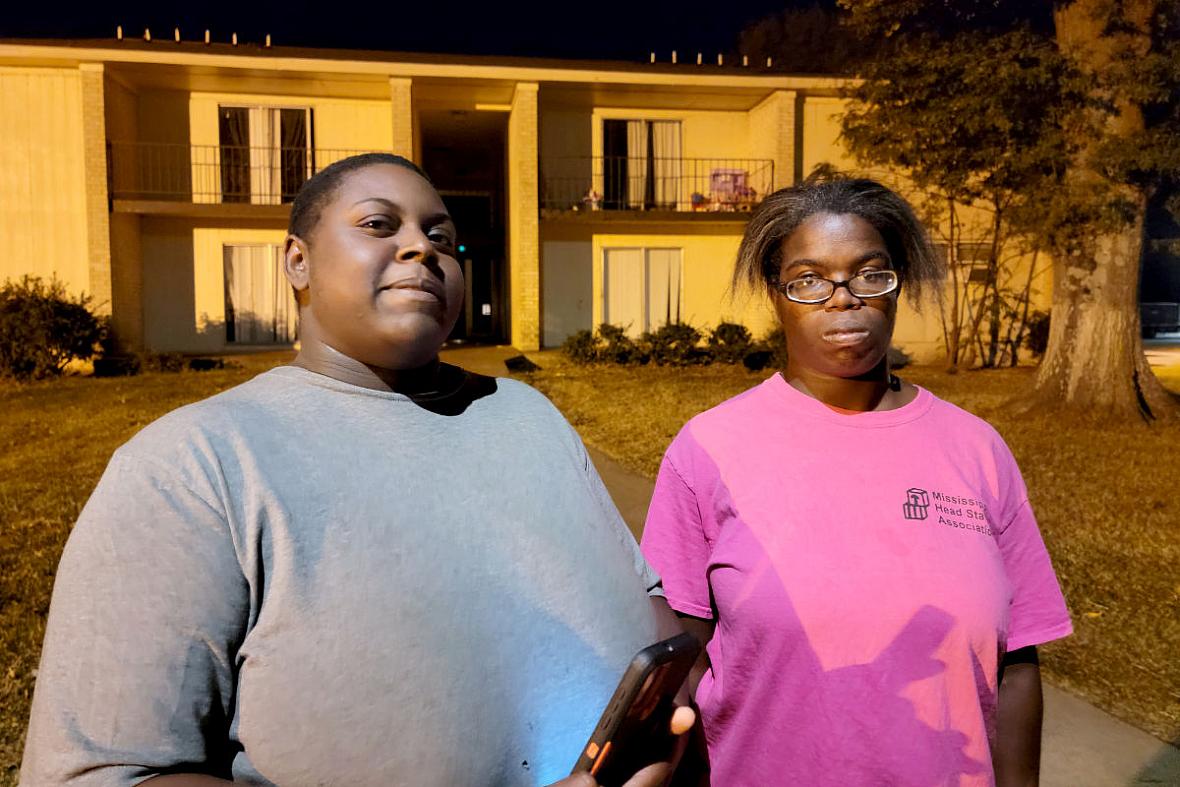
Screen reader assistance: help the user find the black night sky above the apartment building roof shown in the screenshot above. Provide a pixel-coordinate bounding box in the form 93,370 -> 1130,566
0,0 -> 834,60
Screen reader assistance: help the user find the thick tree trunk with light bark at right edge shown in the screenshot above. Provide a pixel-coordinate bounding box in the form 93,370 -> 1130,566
1031,0 -> 1180,421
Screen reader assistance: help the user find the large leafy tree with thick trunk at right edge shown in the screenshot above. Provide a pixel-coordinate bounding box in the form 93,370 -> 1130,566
825,0 -> 1180,421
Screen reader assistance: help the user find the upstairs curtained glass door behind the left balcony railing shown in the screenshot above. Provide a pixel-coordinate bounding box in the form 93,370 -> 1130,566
217,106 -> 313,205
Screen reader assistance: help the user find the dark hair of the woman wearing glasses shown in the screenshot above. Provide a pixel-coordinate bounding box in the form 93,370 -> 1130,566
733,173 -> 945,306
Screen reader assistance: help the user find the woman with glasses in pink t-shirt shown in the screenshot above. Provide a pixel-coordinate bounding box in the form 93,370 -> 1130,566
643,178 -> 1071,787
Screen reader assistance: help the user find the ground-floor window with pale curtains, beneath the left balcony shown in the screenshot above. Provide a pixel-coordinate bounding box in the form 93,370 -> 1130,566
222,243 -> 299,345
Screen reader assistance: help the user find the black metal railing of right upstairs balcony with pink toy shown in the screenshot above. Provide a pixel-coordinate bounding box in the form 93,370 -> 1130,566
540,156 -> 774,211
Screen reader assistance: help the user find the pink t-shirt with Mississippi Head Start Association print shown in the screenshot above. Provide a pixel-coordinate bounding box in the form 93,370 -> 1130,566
643,375 -> 1071,787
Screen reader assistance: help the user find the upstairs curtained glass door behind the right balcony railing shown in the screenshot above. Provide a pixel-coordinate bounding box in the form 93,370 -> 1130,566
602,120 -> 681,210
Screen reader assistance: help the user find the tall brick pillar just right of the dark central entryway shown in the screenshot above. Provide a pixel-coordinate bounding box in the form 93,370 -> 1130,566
509,83 -> 542,350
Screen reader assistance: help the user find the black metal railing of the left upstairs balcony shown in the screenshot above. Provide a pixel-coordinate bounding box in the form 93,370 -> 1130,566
107,142 -> 382,205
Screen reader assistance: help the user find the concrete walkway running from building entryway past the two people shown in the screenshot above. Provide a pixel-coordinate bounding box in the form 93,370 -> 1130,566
443,347 -> 1180,787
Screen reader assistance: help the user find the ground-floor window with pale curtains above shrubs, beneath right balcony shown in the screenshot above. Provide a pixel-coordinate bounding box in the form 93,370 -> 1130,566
602,249 -> 682,336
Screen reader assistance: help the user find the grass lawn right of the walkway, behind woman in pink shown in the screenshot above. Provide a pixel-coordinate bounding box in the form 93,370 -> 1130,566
529,352 -> 1180,741
